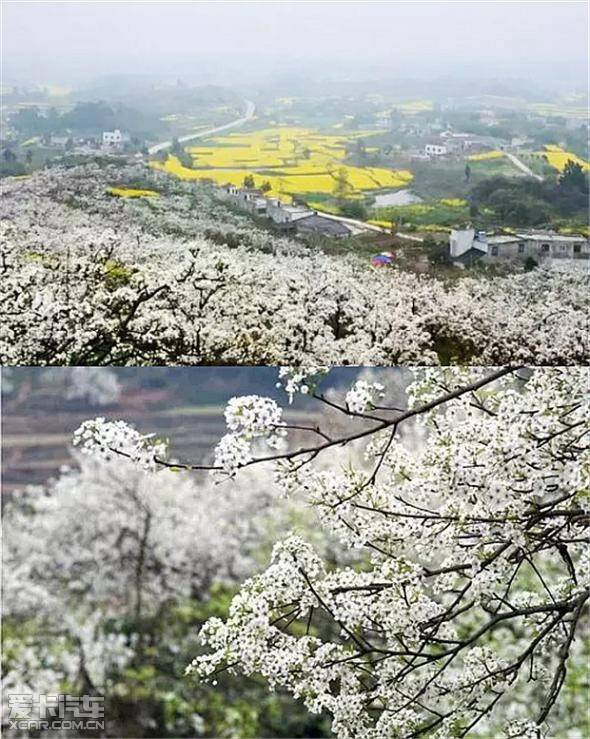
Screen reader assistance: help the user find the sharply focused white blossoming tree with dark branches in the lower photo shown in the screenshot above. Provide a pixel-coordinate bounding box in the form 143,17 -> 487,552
79,367 -> 590,739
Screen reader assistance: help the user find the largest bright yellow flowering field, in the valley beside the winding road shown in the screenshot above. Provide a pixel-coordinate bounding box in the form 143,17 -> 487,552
153,126 -> 412,201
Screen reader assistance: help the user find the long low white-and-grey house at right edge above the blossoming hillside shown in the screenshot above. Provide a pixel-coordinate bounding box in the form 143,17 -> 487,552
449,228 -> 590,269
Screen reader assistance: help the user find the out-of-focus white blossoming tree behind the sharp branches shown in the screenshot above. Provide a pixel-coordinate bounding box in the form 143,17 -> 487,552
2,450 -> 284,736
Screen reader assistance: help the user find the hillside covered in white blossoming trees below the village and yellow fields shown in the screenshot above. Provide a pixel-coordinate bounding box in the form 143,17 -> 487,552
0,164 -> 589,365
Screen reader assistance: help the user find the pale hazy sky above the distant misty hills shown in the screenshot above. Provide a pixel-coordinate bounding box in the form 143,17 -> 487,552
2,0 -> 588,86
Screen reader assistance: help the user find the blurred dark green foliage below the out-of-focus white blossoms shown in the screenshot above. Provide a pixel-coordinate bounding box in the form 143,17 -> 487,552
3,585 -> 330,739
